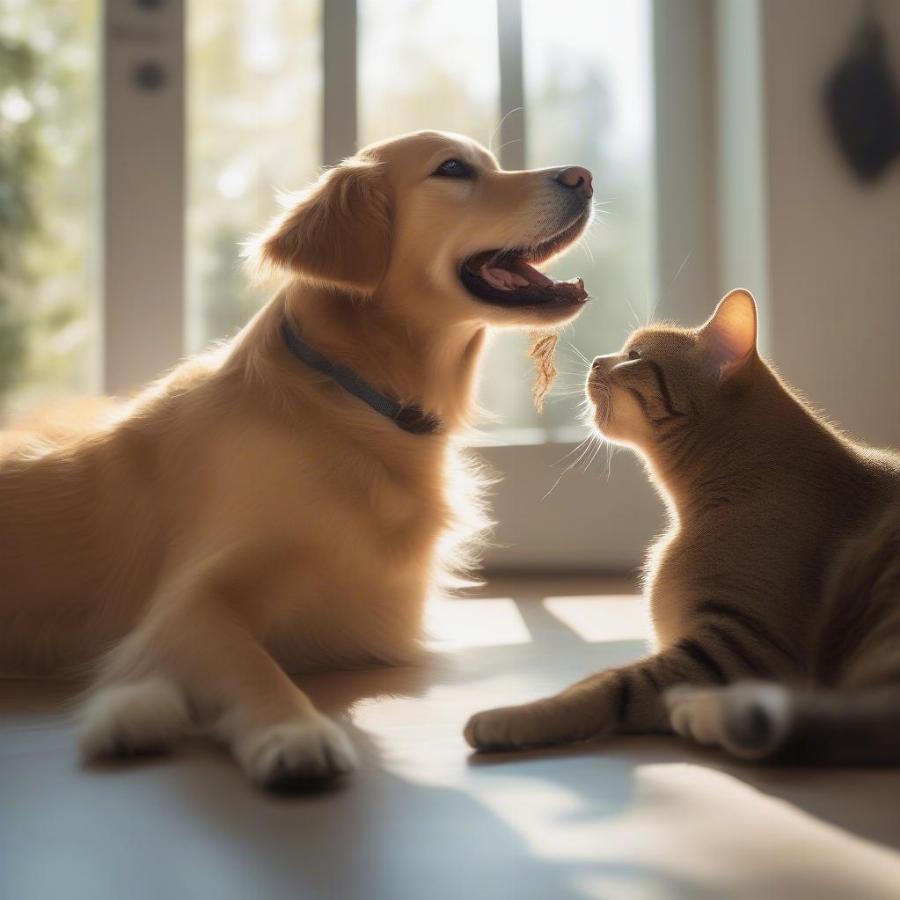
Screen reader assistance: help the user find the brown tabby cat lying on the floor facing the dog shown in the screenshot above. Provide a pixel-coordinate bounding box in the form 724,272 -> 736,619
466,291 -> 900,763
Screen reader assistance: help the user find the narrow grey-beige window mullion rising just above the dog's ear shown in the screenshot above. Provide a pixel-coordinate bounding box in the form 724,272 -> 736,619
322,0 -> 358,166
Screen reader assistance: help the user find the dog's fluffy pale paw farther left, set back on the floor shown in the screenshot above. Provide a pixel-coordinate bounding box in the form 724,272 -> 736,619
79,677 -> 191,761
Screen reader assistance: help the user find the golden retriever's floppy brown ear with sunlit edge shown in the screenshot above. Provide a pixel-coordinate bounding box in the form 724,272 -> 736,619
253,159 -> 391,294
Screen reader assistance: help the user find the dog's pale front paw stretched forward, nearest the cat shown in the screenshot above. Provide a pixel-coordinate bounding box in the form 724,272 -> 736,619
236,716 -> 356,791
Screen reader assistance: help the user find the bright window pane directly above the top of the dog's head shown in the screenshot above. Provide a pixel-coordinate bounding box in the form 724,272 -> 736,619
358,0 -> 500,146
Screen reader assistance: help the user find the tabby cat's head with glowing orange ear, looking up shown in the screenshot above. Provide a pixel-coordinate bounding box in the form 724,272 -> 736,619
587,290 -> 758,453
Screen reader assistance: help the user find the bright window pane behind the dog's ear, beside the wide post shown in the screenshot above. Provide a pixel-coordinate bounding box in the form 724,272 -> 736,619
187,0 -> 322,350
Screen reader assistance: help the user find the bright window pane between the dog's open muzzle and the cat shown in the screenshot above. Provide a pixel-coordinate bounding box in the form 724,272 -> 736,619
483,0 -> 655,436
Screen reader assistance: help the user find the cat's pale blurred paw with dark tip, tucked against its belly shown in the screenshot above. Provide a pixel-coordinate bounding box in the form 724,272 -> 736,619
665,681 -> 791,760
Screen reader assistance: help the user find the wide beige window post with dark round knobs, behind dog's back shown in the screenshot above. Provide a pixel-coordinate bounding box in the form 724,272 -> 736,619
102,0 -> 185,393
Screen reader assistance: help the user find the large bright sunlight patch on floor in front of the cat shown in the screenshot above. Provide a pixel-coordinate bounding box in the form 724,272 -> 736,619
477,757 -> 900,898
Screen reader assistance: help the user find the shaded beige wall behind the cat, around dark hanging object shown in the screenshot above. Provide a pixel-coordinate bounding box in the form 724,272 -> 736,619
761,0 -> 900,447
